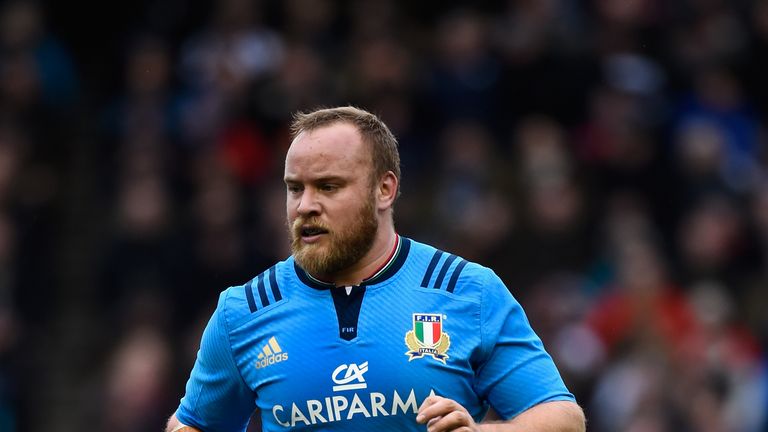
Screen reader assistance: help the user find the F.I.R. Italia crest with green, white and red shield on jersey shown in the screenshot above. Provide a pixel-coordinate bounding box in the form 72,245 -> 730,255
405,313 -> 451,364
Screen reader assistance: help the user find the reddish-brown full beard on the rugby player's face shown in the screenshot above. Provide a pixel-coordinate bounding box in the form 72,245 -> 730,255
290,199 -> 379,278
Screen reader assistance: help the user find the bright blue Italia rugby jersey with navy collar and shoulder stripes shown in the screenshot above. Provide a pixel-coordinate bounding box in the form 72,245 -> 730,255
176,237 -> 574,432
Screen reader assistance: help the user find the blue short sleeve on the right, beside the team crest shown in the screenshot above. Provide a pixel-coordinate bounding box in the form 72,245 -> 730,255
475,271 -> 575,419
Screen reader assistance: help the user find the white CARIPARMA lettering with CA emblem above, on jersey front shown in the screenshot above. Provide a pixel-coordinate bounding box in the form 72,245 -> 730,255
272,362 -> 435,428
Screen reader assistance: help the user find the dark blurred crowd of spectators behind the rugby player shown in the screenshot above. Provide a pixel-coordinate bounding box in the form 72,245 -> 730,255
0,0 -> 768,432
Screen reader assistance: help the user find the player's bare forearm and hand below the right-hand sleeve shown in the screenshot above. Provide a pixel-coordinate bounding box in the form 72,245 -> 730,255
416,396 -> 586,432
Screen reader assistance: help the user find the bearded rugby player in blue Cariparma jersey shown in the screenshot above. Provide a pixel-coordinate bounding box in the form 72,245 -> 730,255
167,107 -> 584,432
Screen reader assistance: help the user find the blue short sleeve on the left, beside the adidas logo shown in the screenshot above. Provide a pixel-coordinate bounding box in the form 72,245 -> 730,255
176,291 -> 256,432
